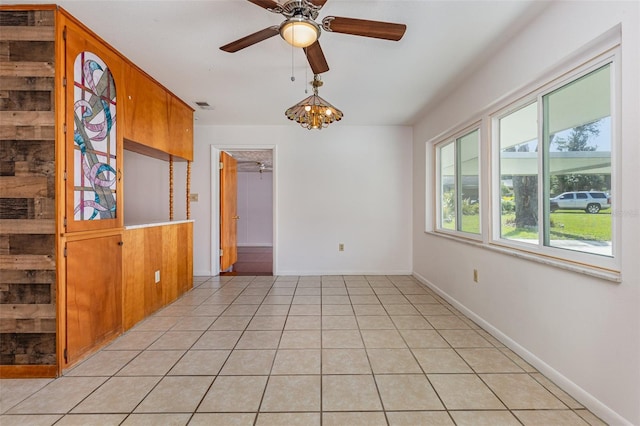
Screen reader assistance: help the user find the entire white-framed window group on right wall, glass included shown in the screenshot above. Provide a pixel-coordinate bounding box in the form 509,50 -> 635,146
427,37 -> 621,279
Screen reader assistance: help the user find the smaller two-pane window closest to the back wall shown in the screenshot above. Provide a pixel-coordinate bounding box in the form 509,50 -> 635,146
436,129 -> 481,235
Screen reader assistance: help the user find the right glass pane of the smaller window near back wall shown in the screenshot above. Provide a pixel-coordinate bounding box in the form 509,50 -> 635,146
457,130 -> 480,234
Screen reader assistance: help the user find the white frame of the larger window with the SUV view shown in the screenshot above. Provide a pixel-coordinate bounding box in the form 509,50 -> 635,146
487,45 -> 621,272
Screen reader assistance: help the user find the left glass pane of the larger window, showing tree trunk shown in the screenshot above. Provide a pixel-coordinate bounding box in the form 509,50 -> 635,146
499,102 -> 539,244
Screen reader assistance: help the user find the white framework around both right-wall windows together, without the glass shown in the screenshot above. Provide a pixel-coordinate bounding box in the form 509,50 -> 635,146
424,24 -> 623,283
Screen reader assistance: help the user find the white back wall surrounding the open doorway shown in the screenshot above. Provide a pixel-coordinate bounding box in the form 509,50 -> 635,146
192,123 -> 412,275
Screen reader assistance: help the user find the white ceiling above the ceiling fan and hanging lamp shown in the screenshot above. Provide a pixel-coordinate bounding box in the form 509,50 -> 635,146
18,0 -> 545,125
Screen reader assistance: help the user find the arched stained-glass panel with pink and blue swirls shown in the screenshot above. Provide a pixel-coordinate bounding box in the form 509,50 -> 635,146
73,52 -> 116,220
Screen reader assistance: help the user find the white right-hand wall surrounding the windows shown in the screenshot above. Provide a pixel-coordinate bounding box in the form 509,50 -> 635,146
413,1 -> 640,424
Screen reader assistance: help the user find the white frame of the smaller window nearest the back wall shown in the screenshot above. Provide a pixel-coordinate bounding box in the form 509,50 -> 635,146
432,120 -> 485,241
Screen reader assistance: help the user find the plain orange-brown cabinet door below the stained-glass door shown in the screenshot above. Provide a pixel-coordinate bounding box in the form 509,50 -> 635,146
65,234 -> 122,365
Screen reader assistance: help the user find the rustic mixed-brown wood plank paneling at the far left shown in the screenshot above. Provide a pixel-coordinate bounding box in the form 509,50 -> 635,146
0,9 -> 56,366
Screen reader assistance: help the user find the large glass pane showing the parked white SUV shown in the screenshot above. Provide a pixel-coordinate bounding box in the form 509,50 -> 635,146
543,65 -> 613,256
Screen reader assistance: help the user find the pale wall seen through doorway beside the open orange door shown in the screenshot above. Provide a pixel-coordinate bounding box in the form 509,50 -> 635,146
238,172 -> 273,247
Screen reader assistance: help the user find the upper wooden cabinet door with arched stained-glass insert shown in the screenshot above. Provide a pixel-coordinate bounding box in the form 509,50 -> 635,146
65,23 -> 123,232
